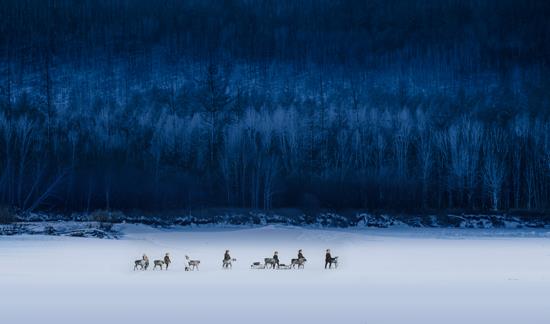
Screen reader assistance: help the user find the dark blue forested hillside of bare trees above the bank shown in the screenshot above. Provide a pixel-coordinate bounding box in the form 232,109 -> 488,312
0,0 -> 550,211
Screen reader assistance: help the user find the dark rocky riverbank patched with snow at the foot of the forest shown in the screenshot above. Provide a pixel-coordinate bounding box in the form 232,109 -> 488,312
4,209 -> 550,238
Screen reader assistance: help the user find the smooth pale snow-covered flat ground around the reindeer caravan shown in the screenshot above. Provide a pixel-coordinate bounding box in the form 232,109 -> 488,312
0,225 -> 550,324
